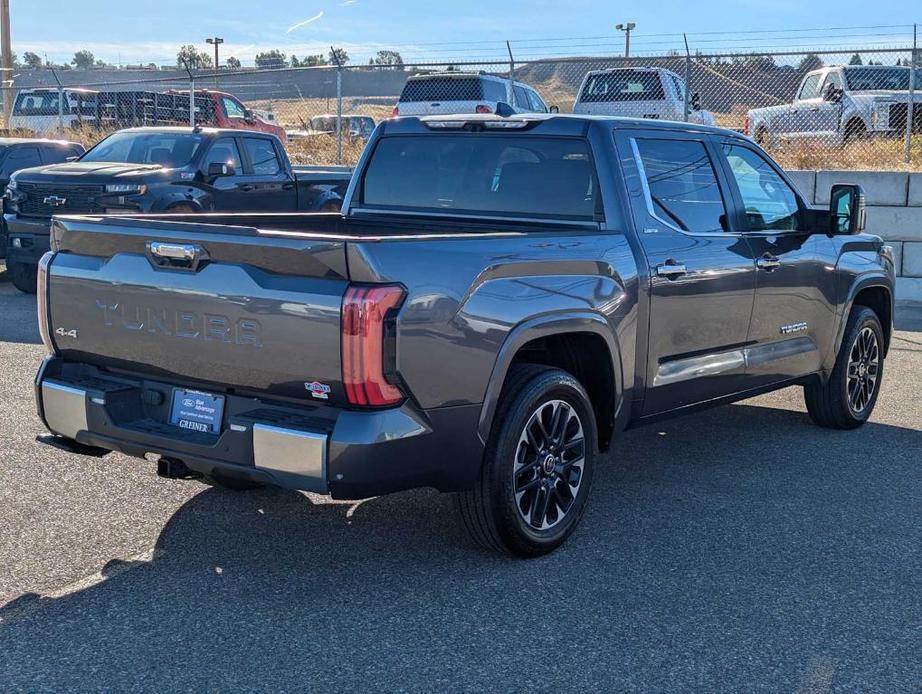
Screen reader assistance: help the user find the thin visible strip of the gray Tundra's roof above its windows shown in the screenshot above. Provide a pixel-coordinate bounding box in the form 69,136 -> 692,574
406,113 -> 741,137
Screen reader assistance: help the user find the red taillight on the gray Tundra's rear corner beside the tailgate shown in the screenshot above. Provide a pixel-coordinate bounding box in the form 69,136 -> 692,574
342,285 -> 403,407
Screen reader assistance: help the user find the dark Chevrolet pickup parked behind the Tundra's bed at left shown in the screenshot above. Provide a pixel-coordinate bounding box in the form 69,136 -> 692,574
4,128 -> 351,292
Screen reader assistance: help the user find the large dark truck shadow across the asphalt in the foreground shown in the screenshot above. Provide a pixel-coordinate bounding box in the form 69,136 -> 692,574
0,405 -> 922,691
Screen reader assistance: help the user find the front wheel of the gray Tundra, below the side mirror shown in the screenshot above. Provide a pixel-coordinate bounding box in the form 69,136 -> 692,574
804,306 -> 884,429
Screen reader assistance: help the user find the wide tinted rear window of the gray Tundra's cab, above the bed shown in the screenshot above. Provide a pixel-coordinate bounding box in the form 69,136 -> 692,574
362,135 -> 598,221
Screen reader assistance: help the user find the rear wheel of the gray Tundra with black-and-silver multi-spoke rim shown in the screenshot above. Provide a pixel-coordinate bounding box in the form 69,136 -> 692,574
458,364 -> 598,557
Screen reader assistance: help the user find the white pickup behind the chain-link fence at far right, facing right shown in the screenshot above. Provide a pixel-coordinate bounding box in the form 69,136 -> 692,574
743,65 -> 922,146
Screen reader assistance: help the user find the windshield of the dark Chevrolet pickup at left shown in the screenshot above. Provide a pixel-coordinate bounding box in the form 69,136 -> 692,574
80,132 -> 202,169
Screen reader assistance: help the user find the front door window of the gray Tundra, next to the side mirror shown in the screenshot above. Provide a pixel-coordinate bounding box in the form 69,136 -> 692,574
723,144 -> 800,231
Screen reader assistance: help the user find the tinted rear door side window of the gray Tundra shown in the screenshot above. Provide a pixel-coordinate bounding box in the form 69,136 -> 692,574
633,139 -> 728,233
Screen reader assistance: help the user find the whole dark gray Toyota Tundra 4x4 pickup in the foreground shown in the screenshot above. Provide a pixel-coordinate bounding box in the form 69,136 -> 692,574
35,114 -> 894,556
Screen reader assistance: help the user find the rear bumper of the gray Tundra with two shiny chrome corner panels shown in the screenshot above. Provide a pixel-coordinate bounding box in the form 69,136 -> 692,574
35,357 -> 483,499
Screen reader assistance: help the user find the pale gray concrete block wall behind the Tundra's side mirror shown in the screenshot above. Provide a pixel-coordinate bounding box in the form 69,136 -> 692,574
788,171 -> 922,302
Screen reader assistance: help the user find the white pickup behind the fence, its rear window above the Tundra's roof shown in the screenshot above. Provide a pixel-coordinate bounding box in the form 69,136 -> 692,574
573,67 -> 714,125
